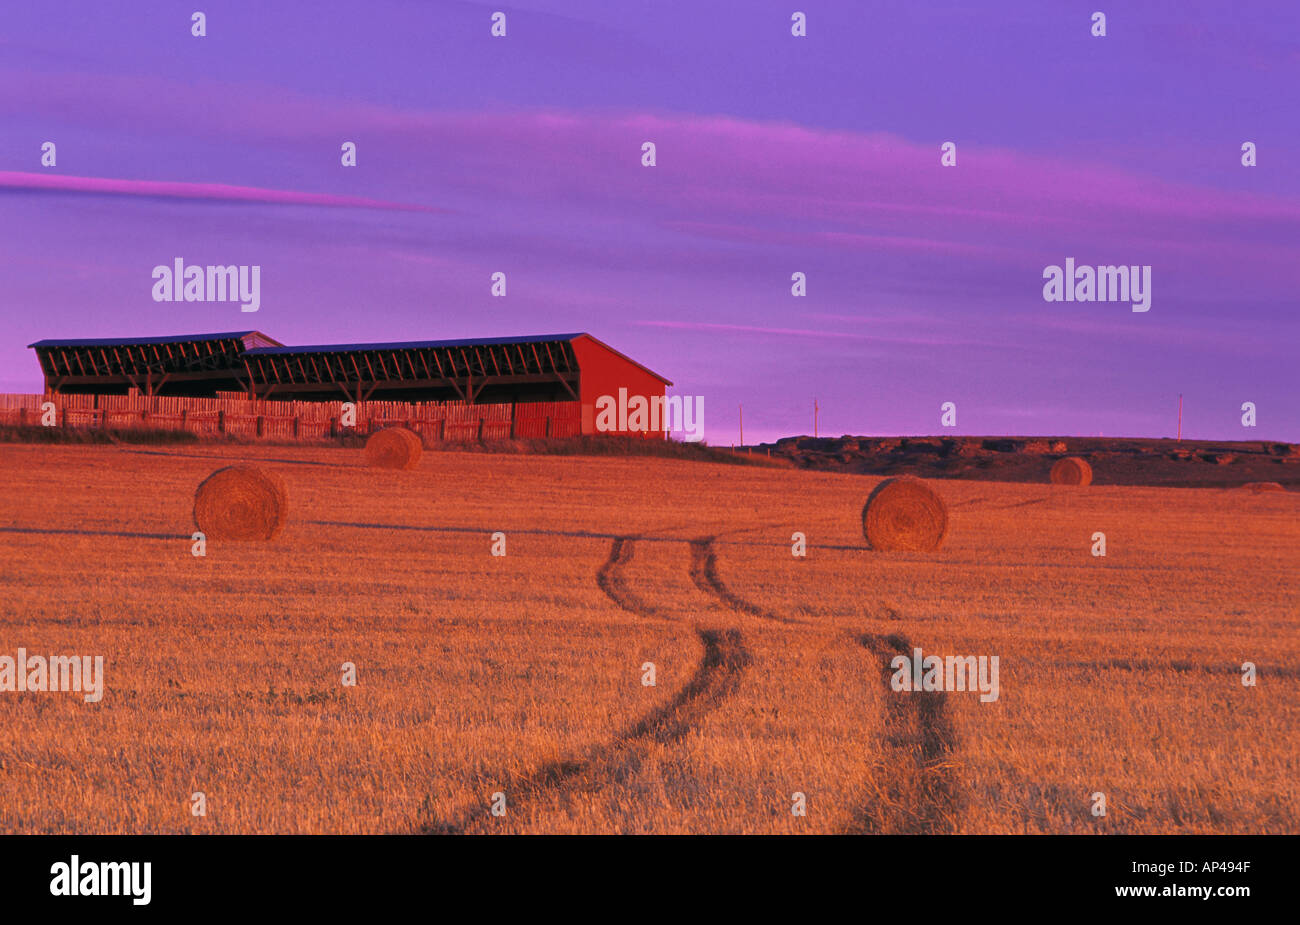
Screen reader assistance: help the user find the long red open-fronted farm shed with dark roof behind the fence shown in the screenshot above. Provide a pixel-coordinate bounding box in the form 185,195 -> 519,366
29,331 -> 672,437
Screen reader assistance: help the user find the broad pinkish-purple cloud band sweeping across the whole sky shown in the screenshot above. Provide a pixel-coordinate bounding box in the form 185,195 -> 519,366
10,63 -> 1300,278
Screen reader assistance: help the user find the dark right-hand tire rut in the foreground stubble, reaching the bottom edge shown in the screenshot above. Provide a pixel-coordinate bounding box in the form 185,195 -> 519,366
844,633 -> 957,835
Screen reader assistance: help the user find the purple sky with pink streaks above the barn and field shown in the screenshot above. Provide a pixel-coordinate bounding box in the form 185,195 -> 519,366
0,0 -> 1300,446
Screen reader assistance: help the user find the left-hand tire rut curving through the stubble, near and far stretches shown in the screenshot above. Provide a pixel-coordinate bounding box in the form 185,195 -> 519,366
424,537 -> 751,835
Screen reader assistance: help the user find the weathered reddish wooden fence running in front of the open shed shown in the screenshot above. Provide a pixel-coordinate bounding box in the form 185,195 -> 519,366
0,394 -> 582,443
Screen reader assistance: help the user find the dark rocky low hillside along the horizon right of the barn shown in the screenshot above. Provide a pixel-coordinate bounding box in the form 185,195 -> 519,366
753,437 -> 1300,488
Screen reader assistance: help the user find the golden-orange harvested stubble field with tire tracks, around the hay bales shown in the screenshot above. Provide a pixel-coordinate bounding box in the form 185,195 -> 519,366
0,444 -> 1300,833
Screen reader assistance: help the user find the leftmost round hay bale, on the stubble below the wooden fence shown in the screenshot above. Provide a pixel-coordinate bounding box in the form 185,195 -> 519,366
194,465 -> 289,540
